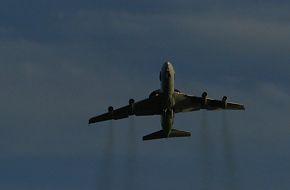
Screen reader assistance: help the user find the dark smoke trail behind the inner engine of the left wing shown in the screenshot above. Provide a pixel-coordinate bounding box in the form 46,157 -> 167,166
124,117 -> 137,190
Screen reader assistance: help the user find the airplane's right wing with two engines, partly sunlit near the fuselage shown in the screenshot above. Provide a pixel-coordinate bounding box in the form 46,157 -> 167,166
174,92 -> 245,113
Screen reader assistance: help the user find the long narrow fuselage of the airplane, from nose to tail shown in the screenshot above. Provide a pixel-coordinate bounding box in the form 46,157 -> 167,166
160,62 -> 175,137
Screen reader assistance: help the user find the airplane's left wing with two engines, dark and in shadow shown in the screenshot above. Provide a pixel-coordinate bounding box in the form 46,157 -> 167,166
89,96 -> 162,124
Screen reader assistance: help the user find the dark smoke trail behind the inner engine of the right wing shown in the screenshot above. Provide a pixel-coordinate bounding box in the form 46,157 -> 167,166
200,111 -> 212,190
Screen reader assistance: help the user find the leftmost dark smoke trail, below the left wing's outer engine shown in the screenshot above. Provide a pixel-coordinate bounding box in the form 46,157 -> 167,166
98,121 -> 114,190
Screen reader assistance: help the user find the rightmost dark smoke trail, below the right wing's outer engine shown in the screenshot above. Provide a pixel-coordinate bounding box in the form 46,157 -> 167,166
222,112 -> 238,190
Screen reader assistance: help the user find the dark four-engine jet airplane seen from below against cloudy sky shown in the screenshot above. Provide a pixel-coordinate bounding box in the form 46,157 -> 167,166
89,61 -> 245,140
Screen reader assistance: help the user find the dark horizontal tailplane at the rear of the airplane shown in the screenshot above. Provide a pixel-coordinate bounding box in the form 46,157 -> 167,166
143,129 -> 191,141
